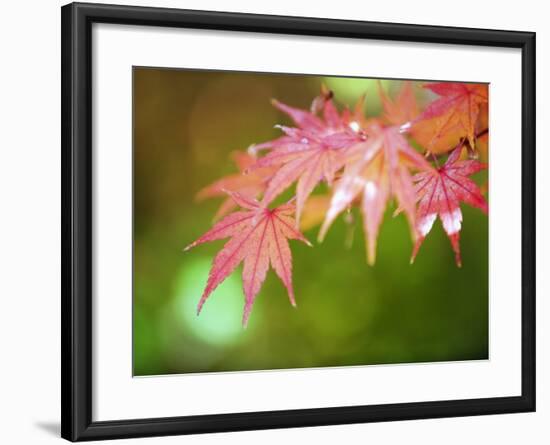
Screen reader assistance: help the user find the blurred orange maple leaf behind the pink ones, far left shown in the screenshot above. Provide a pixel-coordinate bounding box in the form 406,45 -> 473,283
196,151 -> 274,220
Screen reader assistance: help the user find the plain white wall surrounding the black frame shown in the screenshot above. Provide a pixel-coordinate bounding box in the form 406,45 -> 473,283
0,0 -> 550,445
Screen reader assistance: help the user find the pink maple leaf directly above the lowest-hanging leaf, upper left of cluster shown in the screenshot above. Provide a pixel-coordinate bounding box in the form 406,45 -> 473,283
250,95 -> 366,222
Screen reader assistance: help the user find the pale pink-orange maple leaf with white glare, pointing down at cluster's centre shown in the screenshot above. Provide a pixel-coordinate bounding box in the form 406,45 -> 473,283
319,124 -> 432,265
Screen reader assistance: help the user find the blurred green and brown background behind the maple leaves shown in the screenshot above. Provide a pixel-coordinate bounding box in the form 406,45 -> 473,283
133,68 -> 488,376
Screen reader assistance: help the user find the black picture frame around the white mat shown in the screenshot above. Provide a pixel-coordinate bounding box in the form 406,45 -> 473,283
61,3 -> 535,441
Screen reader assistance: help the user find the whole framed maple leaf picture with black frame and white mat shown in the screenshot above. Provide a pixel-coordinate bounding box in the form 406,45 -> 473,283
61,3 -> 535,441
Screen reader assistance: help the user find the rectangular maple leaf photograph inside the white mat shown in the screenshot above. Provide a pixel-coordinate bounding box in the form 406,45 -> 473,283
132,66 -> 491,377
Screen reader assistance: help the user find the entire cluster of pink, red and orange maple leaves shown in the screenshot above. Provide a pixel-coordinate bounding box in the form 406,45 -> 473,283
186,82 -> 488,326
